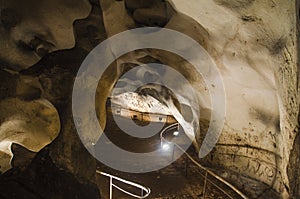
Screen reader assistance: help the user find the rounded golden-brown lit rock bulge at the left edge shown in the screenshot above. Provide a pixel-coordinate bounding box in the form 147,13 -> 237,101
0,71 -> 60,173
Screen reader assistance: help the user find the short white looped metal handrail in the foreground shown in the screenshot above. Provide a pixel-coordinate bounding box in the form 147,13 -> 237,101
96,170 -> 151,199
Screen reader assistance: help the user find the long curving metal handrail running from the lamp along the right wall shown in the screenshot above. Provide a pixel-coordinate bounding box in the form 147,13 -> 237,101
160,123 -> 248,199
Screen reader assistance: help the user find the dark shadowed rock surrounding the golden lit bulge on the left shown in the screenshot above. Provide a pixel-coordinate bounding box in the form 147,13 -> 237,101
0,1 -> 106,199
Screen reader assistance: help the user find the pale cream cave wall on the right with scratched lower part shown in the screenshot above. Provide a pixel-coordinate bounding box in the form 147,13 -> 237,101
174,0 -> 299,198
